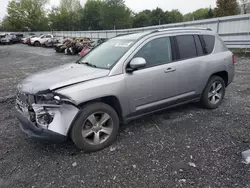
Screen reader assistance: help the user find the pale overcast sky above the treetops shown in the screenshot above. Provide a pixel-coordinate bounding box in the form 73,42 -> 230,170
0,0 -> 216,18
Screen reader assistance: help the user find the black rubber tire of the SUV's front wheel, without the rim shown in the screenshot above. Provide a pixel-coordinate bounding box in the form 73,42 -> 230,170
71,102 -> 120,152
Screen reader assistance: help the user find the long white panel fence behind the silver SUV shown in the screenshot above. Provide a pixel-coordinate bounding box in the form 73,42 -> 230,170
3,14 -> 250,48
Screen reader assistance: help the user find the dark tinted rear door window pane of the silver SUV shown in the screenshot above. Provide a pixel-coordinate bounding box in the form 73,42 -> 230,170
176,35 -> 197,59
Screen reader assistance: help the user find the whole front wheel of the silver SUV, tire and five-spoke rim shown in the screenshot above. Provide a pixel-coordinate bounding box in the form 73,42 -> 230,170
71,102 -> 119,152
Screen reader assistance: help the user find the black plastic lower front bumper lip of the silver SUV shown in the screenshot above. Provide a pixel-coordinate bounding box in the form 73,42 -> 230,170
16,110 -> 67,142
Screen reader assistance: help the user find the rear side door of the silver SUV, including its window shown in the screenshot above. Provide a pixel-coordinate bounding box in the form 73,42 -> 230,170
162,35 -> 203,97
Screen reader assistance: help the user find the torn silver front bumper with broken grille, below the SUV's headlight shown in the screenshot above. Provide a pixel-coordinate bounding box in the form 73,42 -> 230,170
16,92 -> 79,141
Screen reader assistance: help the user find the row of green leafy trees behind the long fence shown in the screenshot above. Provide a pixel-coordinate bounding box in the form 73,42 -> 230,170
0,0 -> 245,31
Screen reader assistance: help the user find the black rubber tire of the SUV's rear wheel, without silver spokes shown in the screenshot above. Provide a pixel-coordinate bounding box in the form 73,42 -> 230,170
200,76 -> 226,109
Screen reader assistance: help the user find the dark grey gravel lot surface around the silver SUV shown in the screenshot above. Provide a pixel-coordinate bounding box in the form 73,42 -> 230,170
0,44 -> 250,188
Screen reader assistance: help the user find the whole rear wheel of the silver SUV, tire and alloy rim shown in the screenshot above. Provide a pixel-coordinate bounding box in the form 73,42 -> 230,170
200,76 -> 226,109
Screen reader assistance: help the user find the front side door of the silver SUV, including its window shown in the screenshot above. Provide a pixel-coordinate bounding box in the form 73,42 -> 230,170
125,37 -> 178,115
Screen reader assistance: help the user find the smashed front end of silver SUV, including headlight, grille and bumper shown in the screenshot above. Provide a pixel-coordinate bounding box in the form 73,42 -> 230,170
16,90 -> 79,140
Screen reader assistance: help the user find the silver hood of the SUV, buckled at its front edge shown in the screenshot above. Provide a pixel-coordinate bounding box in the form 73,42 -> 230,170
18,63 -> 109,94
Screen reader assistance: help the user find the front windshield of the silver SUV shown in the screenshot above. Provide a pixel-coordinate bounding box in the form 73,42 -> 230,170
78,39 -> 135,69
